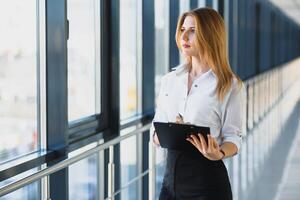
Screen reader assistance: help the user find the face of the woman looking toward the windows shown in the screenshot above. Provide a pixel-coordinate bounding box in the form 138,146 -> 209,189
180,16 -> 199,56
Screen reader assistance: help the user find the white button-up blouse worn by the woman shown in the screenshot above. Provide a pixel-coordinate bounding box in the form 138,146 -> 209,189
150,64 -> 246,151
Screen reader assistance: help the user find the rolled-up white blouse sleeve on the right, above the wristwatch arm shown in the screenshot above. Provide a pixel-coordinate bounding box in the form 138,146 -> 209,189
221,80 -> 246,152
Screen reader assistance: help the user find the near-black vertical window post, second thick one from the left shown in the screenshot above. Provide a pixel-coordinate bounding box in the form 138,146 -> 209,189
101,0 -> 120,197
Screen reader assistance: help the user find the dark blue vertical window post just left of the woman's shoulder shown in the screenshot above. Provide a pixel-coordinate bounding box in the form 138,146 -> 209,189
141,0 -> 155,199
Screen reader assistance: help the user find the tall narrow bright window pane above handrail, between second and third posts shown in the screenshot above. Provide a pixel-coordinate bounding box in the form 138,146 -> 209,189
120,0 -> 138,119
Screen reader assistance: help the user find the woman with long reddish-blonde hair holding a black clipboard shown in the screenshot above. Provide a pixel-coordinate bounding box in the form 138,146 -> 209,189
151,8 -> 245,200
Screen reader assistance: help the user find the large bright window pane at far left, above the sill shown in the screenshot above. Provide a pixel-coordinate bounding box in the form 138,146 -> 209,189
0,0 -> 38,164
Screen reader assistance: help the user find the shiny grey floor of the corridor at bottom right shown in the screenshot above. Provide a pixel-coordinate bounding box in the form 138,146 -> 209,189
246,102 -> 300,200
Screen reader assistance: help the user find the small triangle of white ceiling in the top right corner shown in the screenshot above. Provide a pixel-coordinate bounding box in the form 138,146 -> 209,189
269,0 -> 300,25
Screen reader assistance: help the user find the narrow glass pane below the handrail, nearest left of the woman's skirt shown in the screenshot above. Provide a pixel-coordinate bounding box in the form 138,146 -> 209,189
120,129 -> 138,200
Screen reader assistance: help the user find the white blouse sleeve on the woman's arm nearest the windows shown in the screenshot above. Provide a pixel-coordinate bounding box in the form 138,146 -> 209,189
150,76 -> 168,140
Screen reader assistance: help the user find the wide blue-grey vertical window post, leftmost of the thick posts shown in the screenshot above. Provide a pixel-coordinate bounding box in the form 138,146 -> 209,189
46,0 -> 68,199
